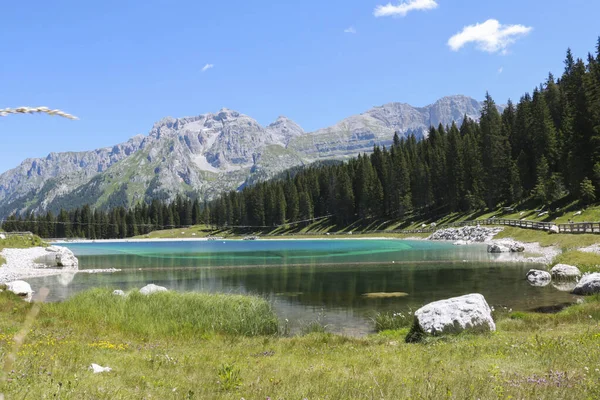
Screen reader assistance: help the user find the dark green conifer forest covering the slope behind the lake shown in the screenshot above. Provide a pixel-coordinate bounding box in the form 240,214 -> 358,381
3,38 -> 600,238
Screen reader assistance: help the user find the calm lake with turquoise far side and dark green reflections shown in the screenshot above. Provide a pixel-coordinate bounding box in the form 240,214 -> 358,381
25,240 -> 573,335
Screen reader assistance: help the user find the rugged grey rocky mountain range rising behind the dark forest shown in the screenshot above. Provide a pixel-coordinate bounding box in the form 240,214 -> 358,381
0,95 -> 496,218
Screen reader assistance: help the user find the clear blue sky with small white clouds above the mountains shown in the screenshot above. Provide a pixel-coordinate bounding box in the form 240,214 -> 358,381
0,0 -> 600,172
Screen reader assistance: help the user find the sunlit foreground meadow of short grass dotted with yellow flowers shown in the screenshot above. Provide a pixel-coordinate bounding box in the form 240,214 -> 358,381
0,292 -> 600,400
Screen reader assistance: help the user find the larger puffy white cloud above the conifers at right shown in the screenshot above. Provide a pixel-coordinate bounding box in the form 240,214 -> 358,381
448,19 -> 533,54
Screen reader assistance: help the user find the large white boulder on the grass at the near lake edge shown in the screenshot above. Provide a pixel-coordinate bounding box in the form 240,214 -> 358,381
415,293 -> 496,335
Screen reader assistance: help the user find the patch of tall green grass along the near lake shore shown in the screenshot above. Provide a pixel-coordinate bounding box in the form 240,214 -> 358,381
42,289 -> 278,338
